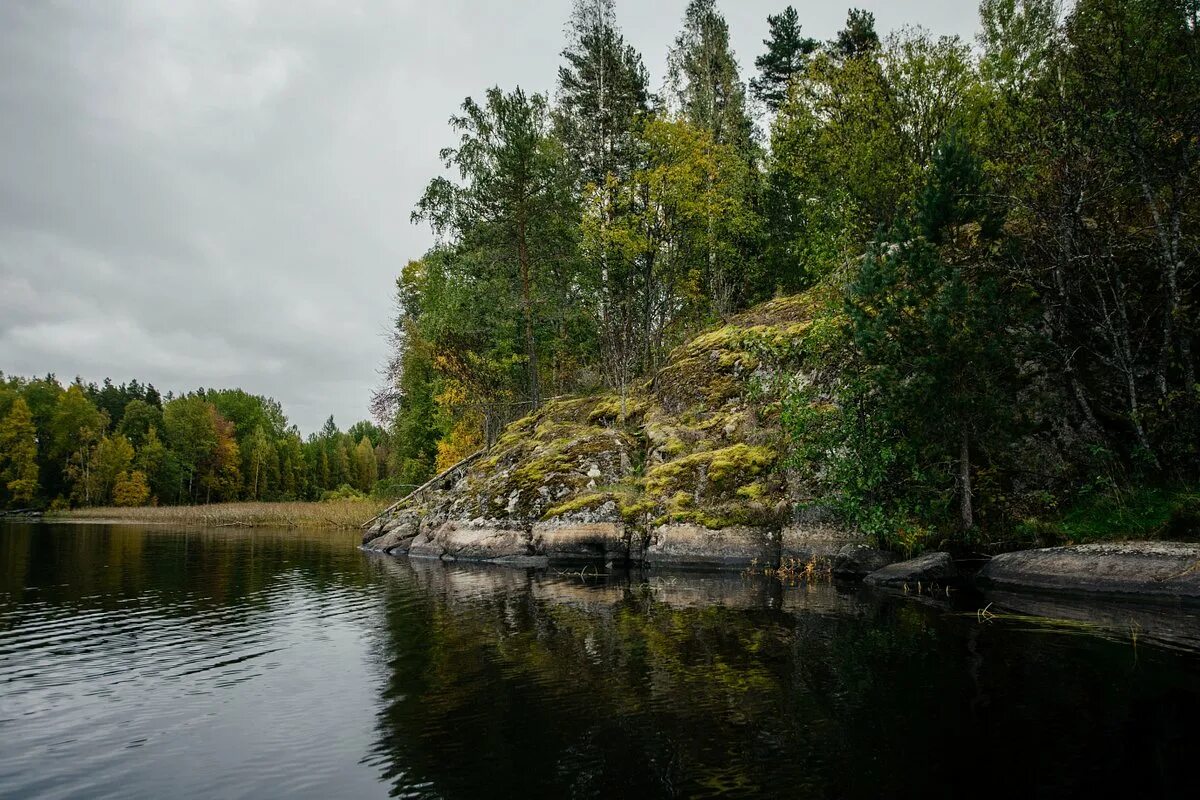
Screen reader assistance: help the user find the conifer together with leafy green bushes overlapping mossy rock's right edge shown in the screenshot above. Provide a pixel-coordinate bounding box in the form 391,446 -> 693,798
785,134 -> 1020,552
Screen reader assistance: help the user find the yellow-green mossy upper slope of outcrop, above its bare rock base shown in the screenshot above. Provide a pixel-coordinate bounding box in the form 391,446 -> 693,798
427,287 -> 829,528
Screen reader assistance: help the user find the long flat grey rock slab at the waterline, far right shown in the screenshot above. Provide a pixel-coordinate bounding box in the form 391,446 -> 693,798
978,542 -> 1200,600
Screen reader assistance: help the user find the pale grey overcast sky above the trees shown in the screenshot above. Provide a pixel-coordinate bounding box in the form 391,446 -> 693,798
0,0 -> 976,433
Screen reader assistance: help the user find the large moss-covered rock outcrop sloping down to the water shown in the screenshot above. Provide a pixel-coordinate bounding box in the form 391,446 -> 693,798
364,295 -> 859,569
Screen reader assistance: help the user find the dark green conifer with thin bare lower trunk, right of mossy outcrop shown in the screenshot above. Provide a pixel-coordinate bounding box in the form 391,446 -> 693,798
847,134 -> 1016,531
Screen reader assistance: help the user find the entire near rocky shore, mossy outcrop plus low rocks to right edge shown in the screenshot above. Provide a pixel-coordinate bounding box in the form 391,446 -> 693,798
362,295 -> 1200,599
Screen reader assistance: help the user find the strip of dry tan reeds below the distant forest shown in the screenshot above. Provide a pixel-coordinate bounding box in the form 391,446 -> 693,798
44,500 -> 390,530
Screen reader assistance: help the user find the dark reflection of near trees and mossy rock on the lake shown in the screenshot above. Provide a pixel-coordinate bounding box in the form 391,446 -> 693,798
368,559 -> 1200,798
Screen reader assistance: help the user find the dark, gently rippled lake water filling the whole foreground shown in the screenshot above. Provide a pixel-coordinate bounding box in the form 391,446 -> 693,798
0,525 -> 1200,800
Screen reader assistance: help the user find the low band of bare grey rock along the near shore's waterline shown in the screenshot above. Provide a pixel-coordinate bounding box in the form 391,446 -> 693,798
362,512 -> 1200,602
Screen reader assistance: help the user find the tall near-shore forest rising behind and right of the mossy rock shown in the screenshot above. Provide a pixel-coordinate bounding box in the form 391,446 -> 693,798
376,0 -> 1200,544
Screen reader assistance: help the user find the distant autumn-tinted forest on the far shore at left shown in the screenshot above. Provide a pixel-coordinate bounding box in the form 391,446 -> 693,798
0,374 -> 390,509
